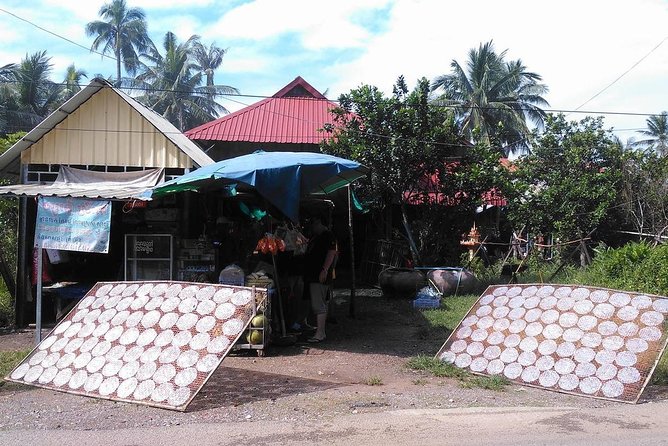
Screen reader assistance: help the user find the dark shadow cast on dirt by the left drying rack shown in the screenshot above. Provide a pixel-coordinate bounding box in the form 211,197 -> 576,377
188,367 -> 341,412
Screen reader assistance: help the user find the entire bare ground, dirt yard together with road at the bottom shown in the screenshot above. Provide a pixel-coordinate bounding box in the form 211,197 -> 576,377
0,288 -> 668,446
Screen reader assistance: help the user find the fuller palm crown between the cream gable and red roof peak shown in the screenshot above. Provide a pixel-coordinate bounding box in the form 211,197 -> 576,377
135,32 -> 238,131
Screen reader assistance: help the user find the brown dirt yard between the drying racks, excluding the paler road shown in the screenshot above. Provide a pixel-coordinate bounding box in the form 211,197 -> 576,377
0,290 -> 668,430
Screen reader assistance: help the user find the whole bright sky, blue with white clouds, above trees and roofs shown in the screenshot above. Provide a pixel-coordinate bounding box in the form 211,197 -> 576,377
0,0 -> 668,141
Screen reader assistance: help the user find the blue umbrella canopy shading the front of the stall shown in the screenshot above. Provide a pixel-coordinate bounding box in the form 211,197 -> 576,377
153,151 -> 368,221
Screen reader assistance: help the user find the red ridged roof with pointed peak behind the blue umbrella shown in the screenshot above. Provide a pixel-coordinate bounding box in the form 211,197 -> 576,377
185,76 -> 337,144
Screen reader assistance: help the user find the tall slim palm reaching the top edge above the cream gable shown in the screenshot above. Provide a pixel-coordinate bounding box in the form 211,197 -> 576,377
86,0 -> 155,83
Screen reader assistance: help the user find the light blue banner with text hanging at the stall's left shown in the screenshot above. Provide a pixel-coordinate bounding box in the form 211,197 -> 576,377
35,197 -> 111,253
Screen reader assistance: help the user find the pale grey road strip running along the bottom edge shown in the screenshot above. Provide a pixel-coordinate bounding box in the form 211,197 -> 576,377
0,402 -> 668,446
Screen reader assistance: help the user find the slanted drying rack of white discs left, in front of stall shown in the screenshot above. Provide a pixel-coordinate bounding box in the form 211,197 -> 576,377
6,282 -> 266,410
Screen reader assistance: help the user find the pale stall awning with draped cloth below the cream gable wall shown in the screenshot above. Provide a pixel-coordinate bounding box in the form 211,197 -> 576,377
0,166 -> 165,201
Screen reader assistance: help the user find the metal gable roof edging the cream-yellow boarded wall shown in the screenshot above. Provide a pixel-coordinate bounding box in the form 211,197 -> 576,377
0,78 -> 213,174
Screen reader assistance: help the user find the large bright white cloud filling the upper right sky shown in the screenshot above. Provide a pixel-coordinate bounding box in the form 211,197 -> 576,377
332,0 -> 668,131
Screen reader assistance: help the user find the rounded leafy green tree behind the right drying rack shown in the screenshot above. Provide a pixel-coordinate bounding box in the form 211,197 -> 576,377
509,114 -> 623,262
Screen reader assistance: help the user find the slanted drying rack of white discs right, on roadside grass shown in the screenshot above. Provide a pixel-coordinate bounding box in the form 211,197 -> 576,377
436,284 -> 668,403
